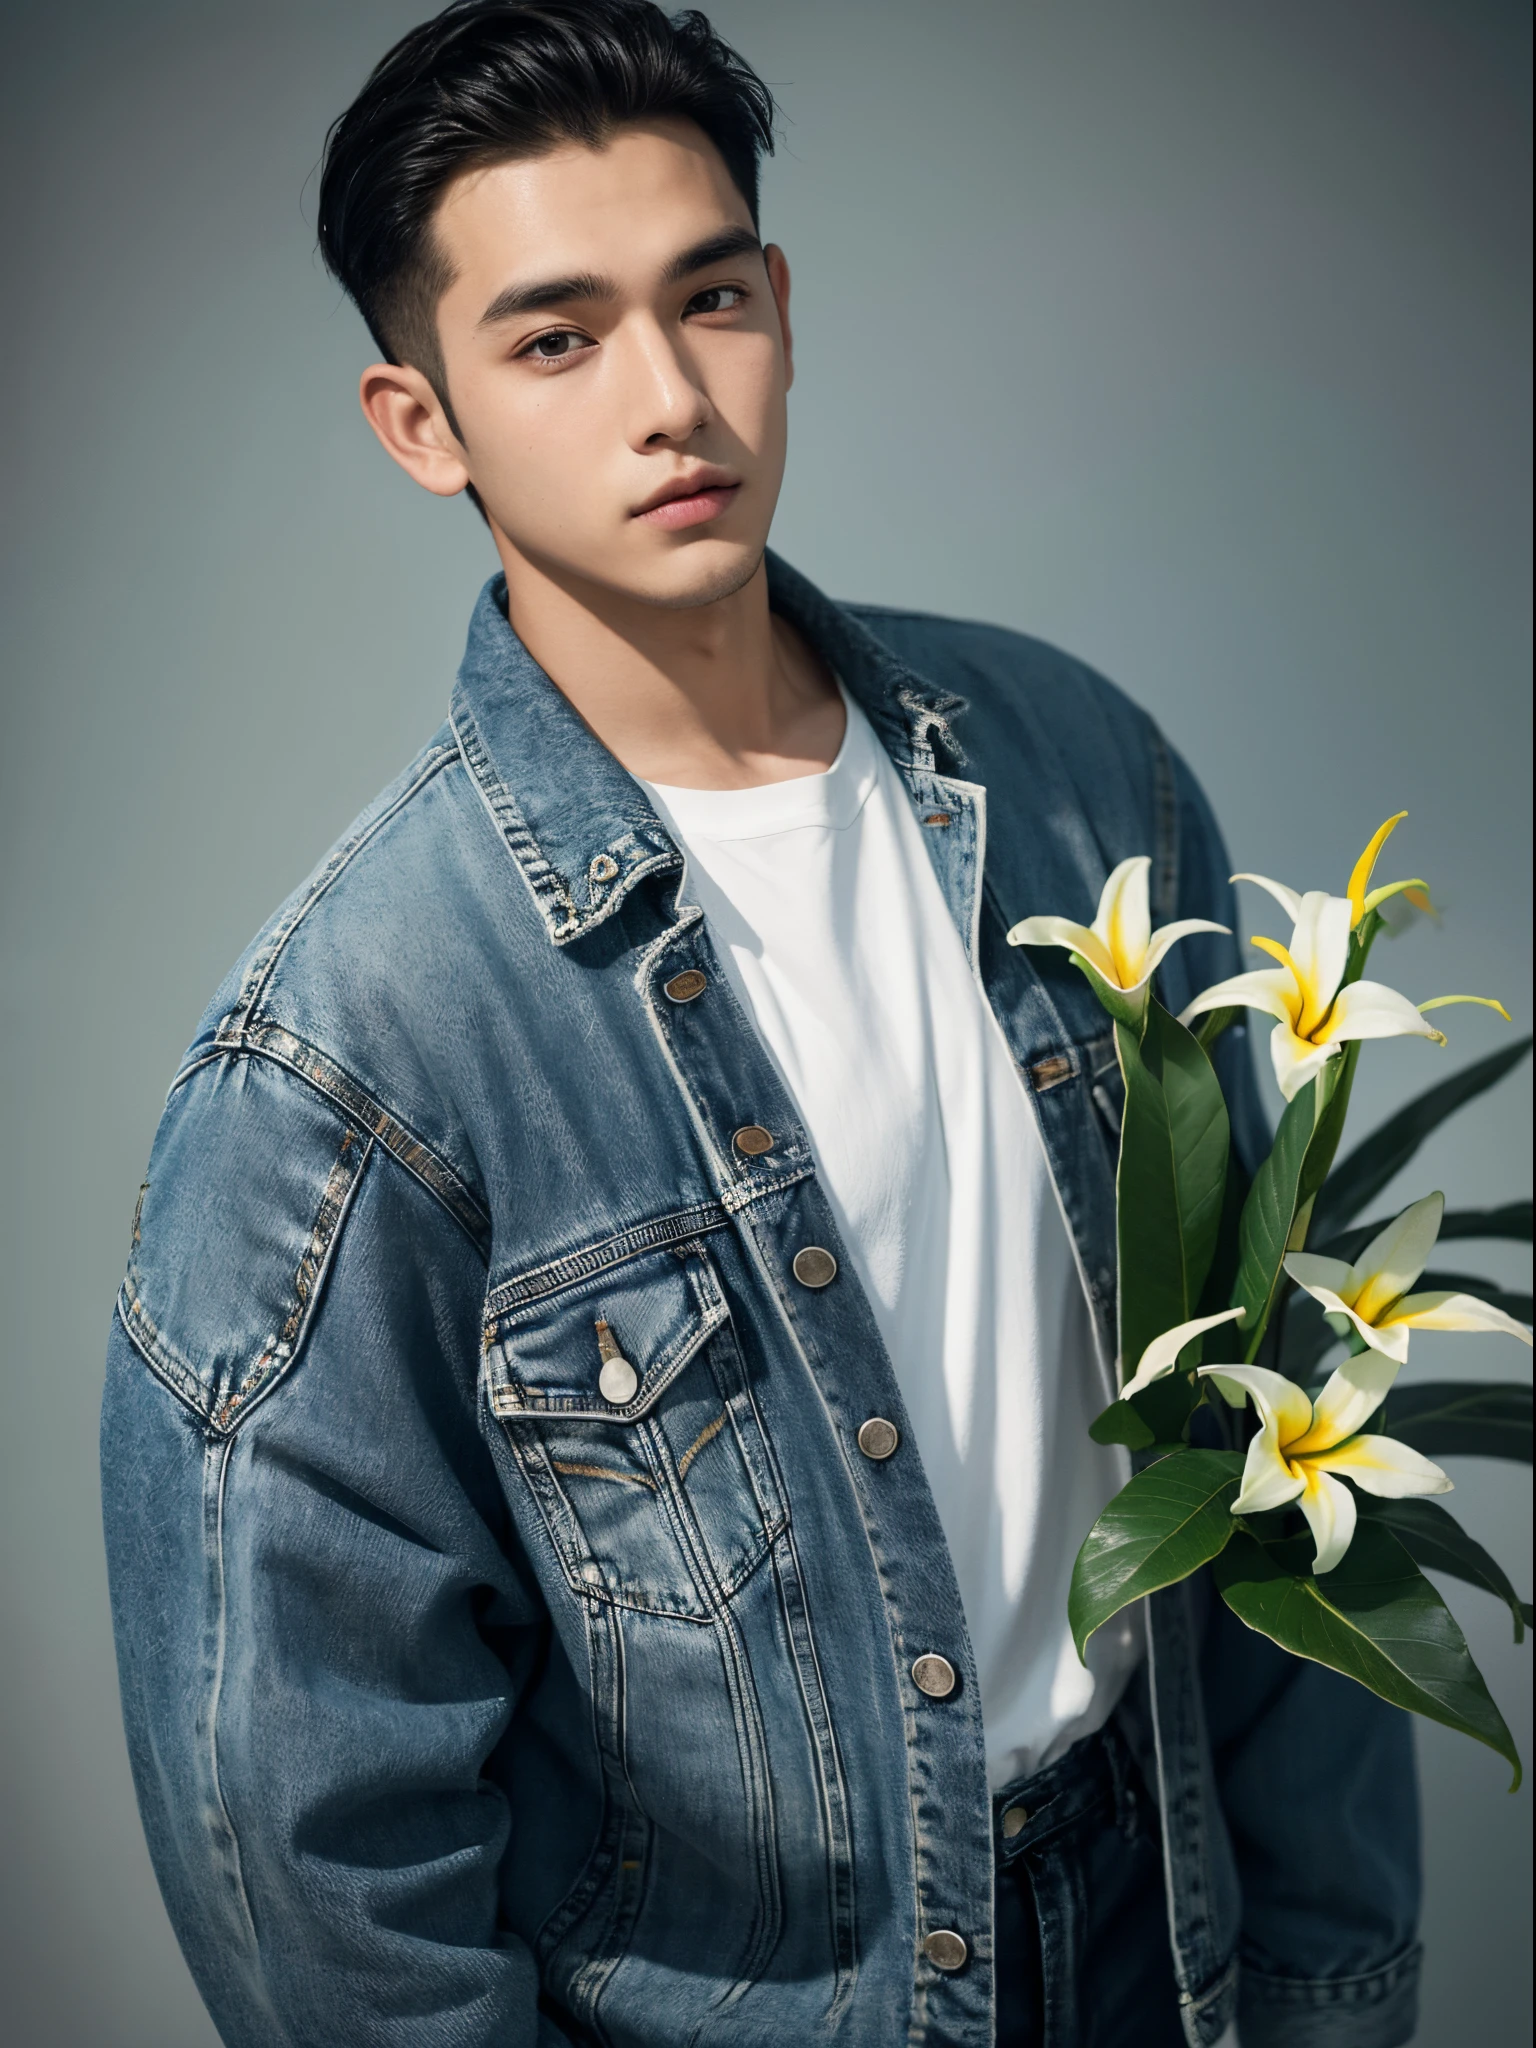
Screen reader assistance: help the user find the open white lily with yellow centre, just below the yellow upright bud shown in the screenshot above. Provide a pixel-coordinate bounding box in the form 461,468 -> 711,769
1180,874 -> 1509,1102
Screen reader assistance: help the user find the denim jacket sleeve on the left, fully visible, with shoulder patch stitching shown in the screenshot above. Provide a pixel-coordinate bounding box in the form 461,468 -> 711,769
102,1059 -> 565,2048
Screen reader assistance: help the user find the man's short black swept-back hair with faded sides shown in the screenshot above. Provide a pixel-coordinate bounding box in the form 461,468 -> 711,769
319,0 -> 774,397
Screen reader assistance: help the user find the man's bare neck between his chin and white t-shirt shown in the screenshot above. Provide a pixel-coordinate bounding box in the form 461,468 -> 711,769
496,532 -> 844,788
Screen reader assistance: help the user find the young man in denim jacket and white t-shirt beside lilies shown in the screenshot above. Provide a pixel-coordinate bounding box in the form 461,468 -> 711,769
104,0 -> 1415,2048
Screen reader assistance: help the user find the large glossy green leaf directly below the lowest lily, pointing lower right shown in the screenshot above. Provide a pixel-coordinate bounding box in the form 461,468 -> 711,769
1214,1518 -> 1520,1792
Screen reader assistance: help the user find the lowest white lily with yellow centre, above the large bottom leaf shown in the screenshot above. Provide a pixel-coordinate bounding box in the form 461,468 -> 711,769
1200,1352 -> 1452,1573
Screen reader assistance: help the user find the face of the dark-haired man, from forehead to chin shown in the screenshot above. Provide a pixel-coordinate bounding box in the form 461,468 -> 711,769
434,121 -> 791,606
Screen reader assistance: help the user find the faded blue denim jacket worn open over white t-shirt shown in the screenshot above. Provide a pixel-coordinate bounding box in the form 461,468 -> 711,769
102,559 -> 1417,2048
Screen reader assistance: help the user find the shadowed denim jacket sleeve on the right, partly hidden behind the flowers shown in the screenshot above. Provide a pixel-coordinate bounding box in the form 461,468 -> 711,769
1174,758 -> 1419,2048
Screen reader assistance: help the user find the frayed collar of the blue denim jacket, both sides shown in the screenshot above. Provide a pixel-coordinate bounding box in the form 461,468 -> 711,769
451,553 -> 965,946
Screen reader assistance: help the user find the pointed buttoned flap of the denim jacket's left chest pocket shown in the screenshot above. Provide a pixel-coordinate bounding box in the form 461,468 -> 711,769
485,1243 -> 729,1421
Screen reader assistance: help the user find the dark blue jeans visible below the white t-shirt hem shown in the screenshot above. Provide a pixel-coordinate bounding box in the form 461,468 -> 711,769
993,1722 -> 1184,2048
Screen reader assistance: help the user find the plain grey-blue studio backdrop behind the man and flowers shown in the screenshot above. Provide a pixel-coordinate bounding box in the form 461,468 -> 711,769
0,0 -> 1532,2048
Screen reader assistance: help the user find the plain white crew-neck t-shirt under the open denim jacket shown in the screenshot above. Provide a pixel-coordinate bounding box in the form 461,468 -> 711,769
645,698 -> 1141,1790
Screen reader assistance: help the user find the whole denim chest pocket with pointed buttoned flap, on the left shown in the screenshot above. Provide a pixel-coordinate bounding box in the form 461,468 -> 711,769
485,1241 -> 786,1622
